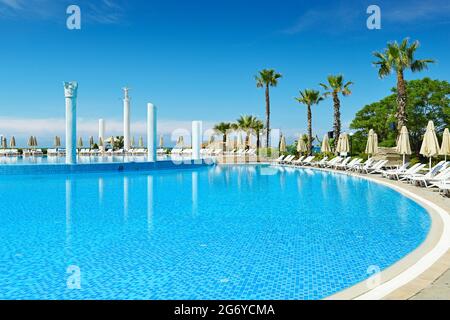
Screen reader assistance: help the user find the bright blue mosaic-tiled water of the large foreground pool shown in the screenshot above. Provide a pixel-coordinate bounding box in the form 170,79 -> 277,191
0,166 -> 430,299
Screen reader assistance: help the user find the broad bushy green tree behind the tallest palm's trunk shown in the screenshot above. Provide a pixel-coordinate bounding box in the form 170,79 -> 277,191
350,78 -> 450,155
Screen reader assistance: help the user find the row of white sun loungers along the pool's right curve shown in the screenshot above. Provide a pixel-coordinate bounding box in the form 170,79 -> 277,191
272,156 -> 450,195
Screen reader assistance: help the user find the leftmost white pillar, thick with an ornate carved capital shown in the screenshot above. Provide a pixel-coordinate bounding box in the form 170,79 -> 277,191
64,81 -> 78,164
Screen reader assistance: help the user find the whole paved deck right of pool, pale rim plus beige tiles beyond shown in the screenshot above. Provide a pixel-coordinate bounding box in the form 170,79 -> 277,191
264,166 -> 450,300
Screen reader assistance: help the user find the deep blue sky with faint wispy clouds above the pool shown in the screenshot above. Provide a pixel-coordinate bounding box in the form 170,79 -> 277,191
0,0 -> 450,143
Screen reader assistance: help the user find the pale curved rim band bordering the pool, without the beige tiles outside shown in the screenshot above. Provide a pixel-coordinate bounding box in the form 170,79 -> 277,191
268,165 -> 450,300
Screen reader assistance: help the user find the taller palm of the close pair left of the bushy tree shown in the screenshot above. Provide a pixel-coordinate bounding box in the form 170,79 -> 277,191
320,75 -> 353,147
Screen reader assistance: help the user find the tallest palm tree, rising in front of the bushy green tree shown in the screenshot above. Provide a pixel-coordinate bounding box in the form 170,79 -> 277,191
373,38 -> 434,130
